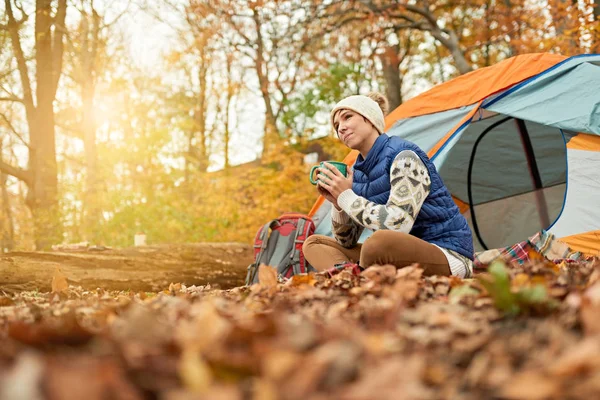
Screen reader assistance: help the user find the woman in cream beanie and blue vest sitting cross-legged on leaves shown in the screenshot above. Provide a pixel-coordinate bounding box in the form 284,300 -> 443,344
303,93 -> 473,278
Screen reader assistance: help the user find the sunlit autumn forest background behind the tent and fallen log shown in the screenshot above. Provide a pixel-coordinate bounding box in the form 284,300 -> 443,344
0,0 -> 600,251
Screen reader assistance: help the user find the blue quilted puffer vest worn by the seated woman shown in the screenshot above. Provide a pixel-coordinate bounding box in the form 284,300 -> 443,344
352,133 -> 473,260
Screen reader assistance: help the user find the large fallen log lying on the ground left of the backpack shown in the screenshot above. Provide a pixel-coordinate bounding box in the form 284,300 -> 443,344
0,243 -> 253,293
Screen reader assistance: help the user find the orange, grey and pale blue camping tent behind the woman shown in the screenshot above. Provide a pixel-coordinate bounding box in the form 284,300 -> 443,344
309,54 -> 600,254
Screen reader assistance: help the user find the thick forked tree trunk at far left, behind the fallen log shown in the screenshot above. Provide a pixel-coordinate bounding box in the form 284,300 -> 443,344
0,0 -> 67,249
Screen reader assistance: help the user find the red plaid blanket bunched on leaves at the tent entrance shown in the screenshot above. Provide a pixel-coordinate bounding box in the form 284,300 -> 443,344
473,230 -> 581,271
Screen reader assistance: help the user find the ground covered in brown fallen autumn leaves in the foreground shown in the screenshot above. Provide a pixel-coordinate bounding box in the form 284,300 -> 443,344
0,255 -> 600,400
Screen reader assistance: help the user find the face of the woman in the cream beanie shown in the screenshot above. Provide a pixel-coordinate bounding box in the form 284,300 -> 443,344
333,109 -> 379,156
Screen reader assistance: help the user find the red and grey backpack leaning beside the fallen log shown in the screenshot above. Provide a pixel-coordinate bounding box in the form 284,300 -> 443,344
246,213 -> 315,285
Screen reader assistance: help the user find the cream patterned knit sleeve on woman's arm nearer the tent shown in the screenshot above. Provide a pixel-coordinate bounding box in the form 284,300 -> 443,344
338,150 -> 431,233
